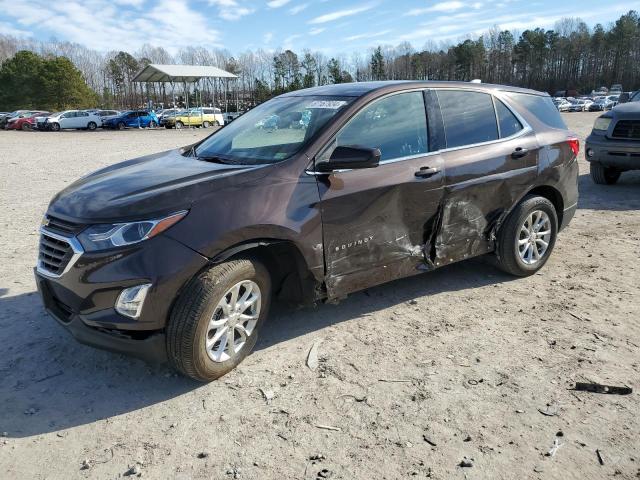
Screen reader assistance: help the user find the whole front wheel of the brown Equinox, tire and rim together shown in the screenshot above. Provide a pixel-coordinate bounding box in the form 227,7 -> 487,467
167,258 -> 271,382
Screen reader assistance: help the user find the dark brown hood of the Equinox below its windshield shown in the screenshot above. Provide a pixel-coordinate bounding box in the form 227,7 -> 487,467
47,150 -> 268,223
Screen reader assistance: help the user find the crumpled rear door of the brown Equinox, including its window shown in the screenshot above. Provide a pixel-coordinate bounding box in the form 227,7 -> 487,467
432,89 -> 539,266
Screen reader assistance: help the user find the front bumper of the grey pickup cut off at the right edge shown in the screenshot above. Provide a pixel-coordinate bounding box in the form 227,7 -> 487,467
585,133 -> 640,170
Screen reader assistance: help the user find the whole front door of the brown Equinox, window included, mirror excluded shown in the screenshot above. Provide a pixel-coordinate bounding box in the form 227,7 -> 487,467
317,90 -> 444,298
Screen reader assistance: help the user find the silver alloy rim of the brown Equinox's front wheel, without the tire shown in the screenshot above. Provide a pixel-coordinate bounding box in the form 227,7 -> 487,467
205,280 -> 262,362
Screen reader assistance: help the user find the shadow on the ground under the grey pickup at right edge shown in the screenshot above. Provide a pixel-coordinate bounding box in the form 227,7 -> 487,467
578,171 -> 640,211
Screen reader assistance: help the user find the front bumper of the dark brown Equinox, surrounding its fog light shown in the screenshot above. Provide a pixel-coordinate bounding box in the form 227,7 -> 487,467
34,235 -> 208,361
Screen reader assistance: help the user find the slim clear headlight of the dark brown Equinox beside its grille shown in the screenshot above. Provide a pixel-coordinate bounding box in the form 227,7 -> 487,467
78,210 -> 187,252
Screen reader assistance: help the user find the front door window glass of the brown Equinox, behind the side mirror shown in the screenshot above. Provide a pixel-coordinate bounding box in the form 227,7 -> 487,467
334,92 -> 428,161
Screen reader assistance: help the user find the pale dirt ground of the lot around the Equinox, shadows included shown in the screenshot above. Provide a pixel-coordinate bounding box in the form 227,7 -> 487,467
0,113 -> 640,480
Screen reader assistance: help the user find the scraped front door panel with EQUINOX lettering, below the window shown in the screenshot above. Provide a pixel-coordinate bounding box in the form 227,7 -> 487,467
318,155 -> 444,298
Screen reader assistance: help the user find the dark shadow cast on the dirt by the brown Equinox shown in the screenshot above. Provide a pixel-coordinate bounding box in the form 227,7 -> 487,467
0,259 -> 513,438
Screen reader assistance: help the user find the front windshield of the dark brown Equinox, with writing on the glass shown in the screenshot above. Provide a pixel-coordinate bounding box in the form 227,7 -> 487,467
194,96 -> 354,165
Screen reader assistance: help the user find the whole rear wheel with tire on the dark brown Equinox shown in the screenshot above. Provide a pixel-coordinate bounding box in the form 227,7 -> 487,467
496,195 -> 558,277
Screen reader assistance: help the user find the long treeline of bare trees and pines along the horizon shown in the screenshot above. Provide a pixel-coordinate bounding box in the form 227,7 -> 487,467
0,11 -> 640,110
